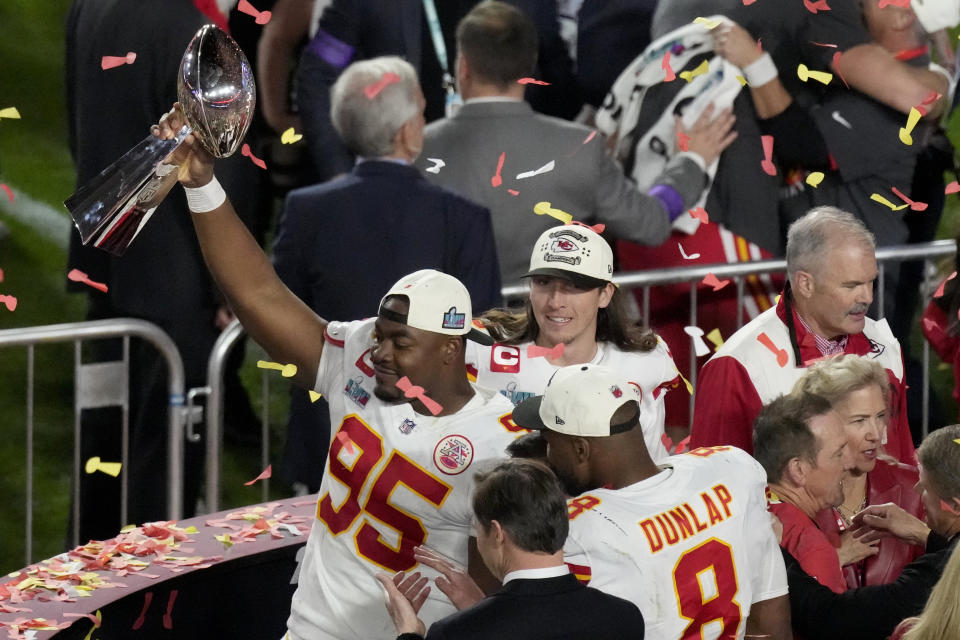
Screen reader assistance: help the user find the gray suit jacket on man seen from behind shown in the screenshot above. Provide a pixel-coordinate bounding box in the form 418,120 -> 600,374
417,102 -> 706,284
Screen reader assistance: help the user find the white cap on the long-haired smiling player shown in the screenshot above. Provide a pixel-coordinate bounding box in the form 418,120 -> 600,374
527,224 -> 613,288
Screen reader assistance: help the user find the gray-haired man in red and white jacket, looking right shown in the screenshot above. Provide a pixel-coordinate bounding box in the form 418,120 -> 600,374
691,207 -> 915,464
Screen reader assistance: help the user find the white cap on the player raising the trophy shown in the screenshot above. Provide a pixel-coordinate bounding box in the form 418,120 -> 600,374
377,269 -> 493,345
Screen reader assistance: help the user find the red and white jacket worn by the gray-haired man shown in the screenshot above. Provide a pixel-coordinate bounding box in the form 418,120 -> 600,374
690,289 -> 916,465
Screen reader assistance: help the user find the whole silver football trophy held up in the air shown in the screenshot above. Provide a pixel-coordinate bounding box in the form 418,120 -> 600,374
64,24 -> 257,256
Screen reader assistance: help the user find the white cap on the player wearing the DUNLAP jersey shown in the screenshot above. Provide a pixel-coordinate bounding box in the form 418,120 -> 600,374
513,364 -> 642,437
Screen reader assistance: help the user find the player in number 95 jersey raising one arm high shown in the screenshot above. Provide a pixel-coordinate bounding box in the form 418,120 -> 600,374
153,109 -> 518,640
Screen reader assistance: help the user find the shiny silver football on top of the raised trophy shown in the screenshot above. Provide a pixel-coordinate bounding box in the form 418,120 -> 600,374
177,24 -> 257,158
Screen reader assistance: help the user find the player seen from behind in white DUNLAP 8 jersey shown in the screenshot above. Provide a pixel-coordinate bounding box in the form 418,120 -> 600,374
513,365 -> 791,640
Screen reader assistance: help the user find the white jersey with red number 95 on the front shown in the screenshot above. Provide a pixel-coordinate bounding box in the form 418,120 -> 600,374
287,319 -> 520,640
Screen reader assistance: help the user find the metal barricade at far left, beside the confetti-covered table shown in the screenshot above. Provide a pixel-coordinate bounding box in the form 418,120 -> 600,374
0,318 -> 185,564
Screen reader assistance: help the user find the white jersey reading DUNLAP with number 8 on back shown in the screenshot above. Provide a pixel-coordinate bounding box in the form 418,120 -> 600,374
564,447 -> 787,640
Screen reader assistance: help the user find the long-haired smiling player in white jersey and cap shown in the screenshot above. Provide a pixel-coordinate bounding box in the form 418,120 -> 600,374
467,225 -> 681,461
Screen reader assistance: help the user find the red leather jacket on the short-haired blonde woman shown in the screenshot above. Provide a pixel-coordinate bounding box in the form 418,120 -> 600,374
812,460 -> 924,589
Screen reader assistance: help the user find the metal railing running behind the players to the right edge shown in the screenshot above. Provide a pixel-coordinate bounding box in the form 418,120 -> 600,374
204,240 -> 957,511
